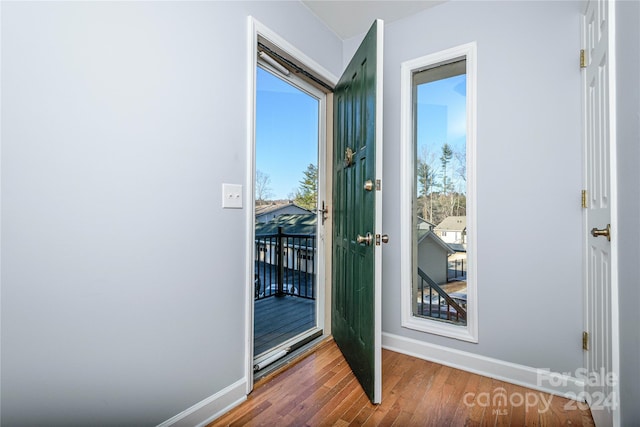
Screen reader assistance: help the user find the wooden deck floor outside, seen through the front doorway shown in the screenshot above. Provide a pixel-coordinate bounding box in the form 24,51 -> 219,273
253,296 -> 316,356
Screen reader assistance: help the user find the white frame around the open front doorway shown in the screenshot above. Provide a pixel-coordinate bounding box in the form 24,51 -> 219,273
244,16 -> 338,394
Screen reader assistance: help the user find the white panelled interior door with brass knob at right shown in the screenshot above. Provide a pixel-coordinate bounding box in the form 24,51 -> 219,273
582,0 -> 618,426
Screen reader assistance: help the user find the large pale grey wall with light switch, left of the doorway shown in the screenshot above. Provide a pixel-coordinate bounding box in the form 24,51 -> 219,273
1,2 -> 342,426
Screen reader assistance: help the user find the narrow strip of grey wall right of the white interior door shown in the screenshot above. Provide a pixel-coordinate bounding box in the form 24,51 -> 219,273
616,1 -> 640,426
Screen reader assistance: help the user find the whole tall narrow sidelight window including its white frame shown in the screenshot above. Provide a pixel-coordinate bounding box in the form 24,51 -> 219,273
402,44 -> 477,341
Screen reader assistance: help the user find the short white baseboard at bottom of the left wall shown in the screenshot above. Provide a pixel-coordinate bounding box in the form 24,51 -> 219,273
158,379 -> 247,427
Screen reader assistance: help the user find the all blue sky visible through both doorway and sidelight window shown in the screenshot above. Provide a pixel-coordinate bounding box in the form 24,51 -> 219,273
256,67 -> 466,199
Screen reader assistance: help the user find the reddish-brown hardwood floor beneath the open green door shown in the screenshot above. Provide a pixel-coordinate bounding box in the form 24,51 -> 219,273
209,339 -> 594,427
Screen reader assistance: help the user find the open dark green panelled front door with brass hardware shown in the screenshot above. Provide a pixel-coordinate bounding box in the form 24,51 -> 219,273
331,20 -> 383,403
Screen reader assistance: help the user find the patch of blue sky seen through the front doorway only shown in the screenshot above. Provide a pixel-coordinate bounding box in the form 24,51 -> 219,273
256,67 -> 319,199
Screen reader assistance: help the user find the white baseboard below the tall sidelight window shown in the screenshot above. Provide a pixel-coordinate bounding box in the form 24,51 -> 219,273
382,333 -> 585,399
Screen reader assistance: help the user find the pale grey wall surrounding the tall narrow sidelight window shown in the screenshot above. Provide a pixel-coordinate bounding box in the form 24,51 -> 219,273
343,1 -> 582,373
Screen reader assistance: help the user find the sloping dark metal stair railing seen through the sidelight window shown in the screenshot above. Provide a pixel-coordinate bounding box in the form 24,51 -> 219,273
418,268 -> 467,323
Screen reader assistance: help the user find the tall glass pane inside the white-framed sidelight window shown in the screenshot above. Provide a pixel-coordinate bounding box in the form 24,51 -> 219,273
413,60 -> 467,326
